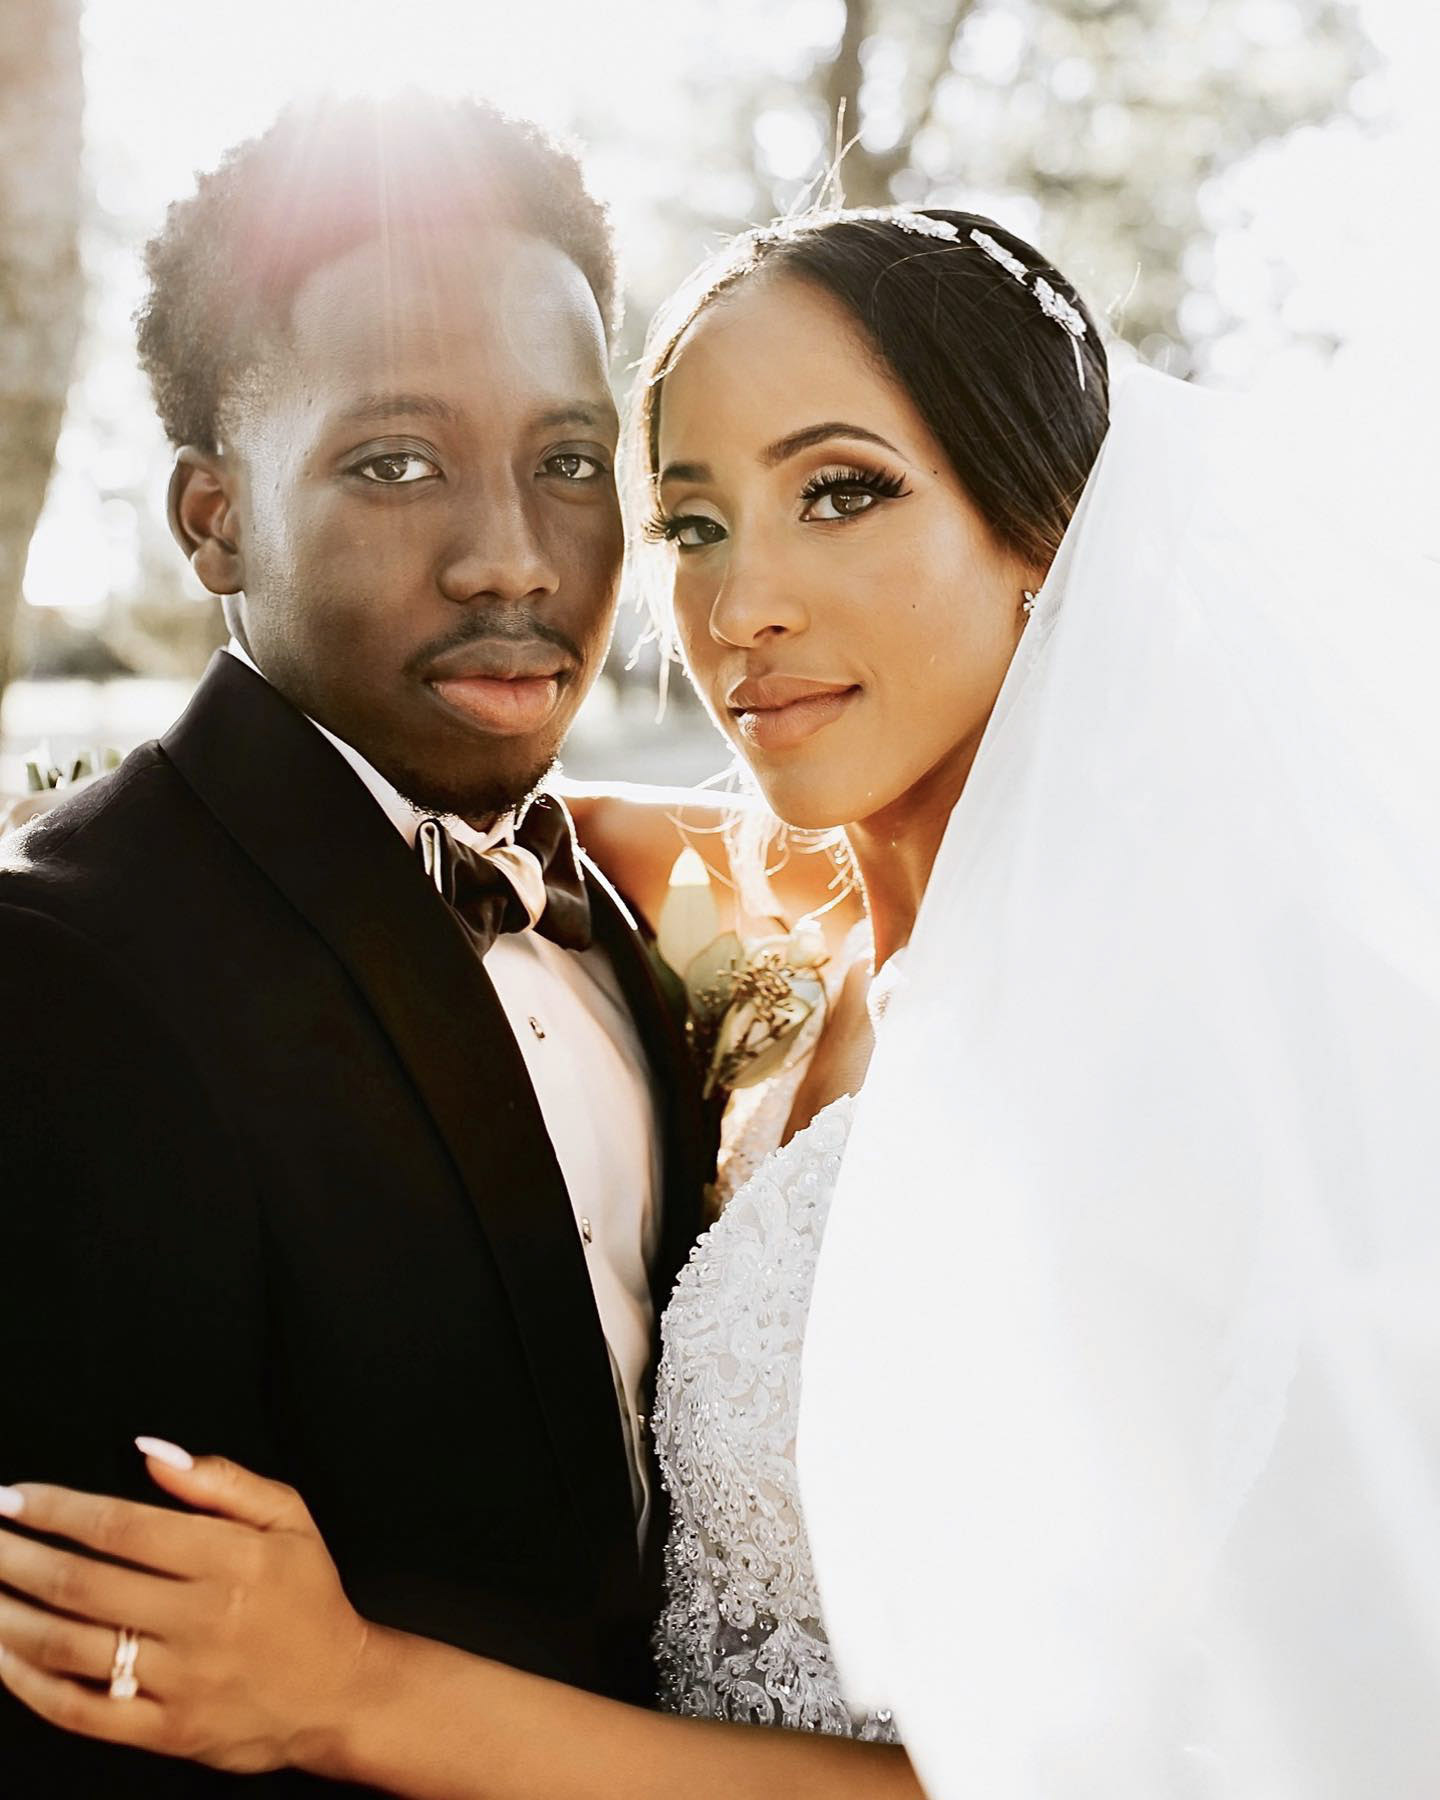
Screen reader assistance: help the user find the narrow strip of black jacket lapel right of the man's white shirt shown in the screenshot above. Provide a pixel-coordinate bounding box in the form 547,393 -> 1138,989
581,855 -> 718,1321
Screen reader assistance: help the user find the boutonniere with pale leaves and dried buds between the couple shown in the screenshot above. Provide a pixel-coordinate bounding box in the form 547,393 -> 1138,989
655,850 -> 828,1100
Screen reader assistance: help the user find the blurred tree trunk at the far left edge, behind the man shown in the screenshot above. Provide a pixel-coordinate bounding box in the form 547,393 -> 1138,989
0,0 -> 83,716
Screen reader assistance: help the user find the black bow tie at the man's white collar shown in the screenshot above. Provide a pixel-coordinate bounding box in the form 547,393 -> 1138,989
416,794 -> 590,956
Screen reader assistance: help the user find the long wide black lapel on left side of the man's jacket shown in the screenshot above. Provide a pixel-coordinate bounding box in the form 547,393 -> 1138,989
162,653 -> 634,1555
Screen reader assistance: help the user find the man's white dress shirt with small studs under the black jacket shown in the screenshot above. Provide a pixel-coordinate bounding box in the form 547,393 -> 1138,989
225,637 -> 661,1546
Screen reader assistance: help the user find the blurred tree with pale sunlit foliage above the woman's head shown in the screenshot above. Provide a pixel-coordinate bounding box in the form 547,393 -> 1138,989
585,0 -> 1375,373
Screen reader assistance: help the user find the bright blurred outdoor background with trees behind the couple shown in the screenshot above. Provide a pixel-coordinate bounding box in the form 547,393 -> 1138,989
0,0 -> 1440,792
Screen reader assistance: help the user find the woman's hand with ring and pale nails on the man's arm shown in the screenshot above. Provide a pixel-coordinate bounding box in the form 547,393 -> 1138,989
0,1445 -> 374,1773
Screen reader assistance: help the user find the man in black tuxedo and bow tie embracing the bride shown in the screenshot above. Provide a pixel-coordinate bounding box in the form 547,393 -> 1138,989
0,103 -> 711,1796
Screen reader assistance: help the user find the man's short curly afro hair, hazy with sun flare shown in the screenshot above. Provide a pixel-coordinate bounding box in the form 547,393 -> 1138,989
135,95 -> 617,452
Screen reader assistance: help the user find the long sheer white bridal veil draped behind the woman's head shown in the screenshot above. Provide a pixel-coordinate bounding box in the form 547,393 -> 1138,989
799,373 -> 1440,1800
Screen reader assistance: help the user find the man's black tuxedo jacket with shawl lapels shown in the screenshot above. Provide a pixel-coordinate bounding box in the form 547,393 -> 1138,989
0,655 -> 713,1800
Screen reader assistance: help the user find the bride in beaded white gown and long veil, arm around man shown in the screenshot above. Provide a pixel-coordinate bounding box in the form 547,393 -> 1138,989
0,200 -> 1440,1800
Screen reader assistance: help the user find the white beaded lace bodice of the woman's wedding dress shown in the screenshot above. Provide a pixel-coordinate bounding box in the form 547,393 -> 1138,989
655,1064 -> 896,1742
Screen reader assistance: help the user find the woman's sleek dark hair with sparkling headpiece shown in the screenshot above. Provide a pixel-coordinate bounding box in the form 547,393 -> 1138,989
630,207 -> 1109,569
